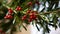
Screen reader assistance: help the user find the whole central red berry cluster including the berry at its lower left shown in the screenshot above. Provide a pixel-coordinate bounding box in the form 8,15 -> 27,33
22,10 -> 37,22
